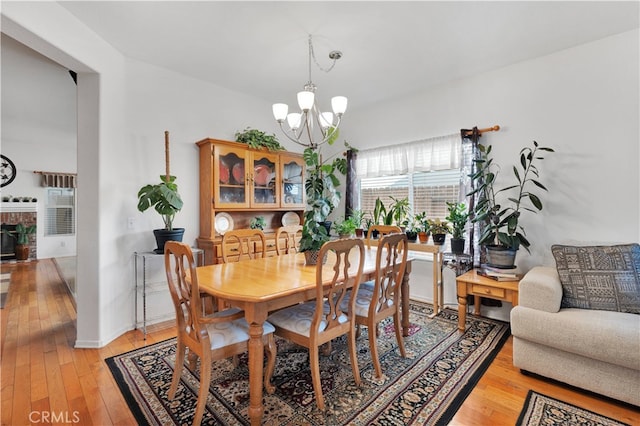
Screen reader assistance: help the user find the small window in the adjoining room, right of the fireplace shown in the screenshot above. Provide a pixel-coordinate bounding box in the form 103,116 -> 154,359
44,188 -> 76,236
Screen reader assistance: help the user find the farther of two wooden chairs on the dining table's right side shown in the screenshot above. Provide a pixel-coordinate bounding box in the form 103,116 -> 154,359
342,234 -> 409,378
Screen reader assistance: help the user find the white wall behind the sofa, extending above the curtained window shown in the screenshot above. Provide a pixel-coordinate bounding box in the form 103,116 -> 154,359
342,30 -> 640,270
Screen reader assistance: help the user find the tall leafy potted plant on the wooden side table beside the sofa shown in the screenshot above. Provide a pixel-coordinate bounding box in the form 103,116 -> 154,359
467,141 -> 554,268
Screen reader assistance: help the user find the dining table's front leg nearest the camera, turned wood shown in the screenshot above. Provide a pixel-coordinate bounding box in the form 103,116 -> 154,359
249,321 -> 264,425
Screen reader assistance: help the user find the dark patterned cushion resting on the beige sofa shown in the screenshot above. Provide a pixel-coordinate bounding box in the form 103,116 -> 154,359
551,244 -> 640,314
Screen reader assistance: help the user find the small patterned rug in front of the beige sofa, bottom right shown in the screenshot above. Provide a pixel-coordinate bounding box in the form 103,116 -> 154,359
516,390 -> 628,426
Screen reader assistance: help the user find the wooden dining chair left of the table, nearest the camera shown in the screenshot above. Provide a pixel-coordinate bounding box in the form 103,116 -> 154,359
164,241 -> 276,425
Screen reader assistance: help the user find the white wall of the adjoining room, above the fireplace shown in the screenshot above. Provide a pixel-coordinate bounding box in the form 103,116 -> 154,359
0,34 -> 77,258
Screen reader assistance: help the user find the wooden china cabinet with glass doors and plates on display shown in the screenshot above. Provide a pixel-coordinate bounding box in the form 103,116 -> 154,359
196,138 -> 305,264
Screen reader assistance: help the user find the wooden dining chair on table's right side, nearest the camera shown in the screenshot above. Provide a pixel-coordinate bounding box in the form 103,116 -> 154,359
267,238 -> 364,410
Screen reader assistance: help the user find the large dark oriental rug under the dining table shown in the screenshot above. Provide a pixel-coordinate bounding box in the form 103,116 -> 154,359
106,301 -> 509,426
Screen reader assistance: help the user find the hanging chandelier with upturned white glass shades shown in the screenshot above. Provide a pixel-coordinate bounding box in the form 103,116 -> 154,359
273,35 -> 347,149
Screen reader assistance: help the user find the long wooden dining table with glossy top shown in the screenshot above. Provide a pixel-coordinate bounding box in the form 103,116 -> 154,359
196,248 -> 412,425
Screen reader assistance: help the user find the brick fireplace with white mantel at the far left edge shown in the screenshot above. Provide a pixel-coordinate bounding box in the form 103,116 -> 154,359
0,202 -> 38,262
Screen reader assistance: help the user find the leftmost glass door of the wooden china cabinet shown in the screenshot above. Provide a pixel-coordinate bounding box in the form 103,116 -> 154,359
214,150 -> 249,207
